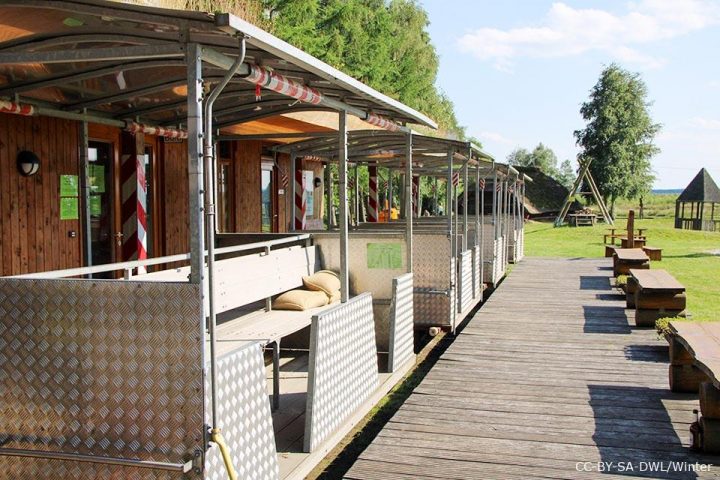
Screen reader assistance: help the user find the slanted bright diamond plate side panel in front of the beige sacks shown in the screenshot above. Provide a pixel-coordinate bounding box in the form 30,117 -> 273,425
303,293 -> 379,452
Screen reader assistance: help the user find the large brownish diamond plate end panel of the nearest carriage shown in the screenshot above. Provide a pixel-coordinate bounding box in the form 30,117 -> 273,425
0,278 -> 204,479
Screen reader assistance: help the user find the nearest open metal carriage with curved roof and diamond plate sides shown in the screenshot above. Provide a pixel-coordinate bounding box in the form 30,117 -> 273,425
0,0 -> 434,479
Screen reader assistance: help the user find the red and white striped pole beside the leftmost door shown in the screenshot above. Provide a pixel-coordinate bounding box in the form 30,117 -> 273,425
120,132 -> 147,273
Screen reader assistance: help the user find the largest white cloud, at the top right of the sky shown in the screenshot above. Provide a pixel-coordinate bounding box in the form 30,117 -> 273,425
458,0 -> 720,71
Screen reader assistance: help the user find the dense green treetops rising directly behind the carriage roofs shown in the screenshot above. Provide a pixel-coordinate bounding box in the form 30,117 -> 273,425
262,0 -> 465,138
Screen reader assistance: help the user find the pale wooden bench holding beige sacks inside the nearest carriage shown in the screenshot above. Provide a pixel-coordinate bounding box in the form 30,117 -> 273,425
133,246 -> 330,409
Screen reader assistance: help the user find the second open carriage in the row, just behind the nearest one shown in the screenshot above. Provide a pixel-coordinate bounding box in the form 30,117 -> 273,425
275,130 -> 492,331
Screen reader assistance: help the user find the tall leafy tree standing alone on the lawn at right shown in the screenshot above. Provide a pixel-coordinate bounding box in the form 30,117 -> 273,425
575,64 -> 660,214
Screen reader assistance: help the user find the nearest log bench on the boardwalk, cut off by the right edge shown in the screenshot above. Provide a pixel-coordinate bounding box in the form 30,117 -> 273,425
666,321 -> 720,454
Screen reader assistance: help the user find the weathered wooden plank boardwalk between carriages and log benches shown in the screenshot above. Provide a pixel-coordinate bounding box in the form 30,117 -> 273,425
345,258 -> 720,480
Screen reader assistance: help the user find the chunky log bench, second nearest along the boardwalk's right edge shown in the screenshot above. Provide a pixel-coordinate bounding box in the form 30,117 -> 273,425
628,268 -> 687,327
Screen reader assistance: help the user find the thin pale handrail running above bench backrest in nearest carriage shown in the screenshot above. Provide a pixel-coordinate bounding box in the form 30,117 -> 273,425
9,234 -> 310,279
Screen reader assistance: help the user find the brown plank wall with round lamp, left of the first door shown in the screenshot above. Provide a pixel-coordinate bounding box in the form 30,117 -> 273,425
0,114 -> 83,275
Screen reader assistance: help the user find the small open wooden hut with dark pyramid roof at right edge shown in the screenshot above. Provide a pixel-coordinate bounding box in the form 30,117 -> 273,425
675,168 -> 720,232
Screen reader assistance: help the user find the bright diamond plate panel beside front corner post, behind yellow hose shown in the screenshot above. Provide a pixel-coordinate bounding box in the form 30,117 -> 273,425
205,342 -> 280,480
